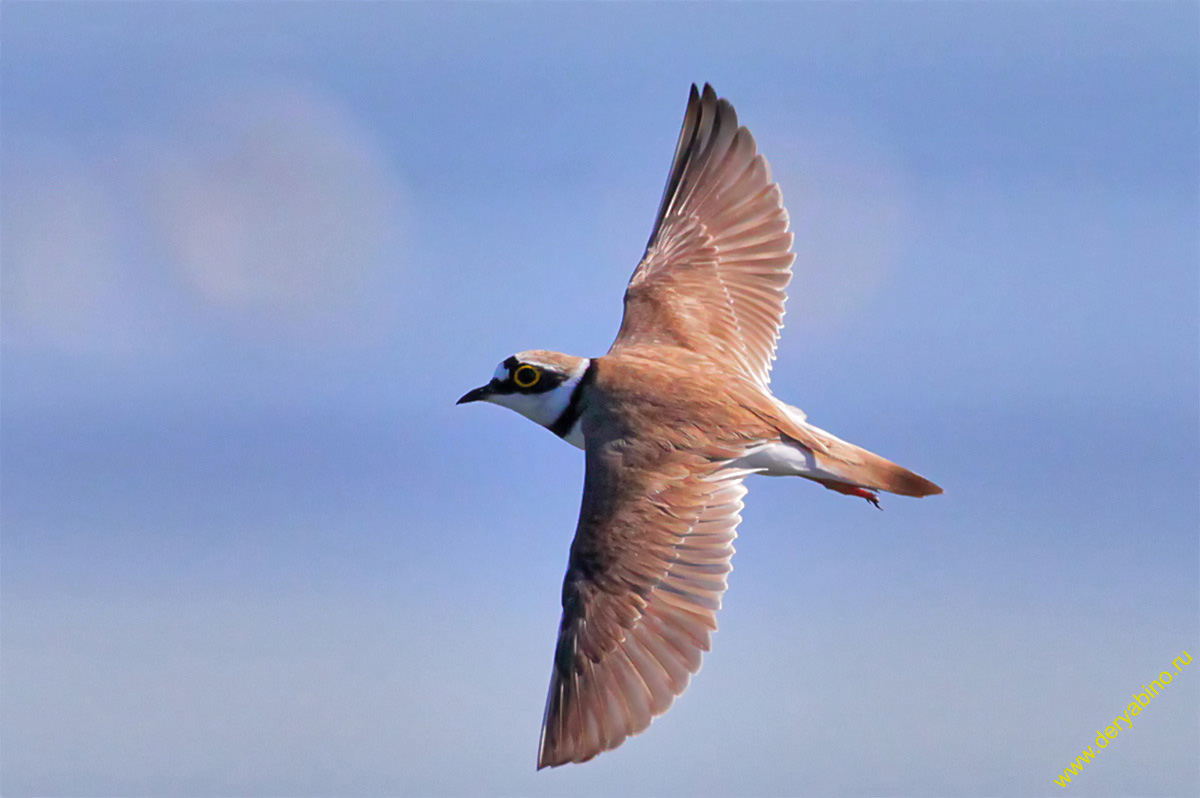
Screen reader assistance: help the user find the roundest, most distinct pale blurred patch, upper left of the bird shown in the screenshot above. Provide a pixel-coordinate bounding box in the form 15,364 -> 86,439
148,89 -> 397,316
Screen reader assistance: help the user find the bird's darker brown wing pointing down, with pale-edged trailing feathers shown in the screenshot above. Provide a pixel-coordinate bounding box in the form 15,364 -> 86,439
538,439 -> 745,768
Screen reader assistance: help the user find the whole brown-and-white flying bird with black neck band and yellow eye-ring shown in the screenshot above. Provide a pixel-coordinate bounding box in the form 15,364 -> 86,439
457,84 -> 942,770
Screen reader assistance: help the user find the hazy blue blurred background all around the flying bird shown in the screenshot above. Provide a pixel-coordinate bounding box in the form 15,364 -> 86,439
0,2 -> 1200,796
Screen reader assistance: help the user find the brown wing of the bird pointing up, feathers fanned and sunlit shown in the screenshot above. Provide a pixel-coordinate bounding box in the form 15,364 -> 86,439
612,84 -> 796,386
